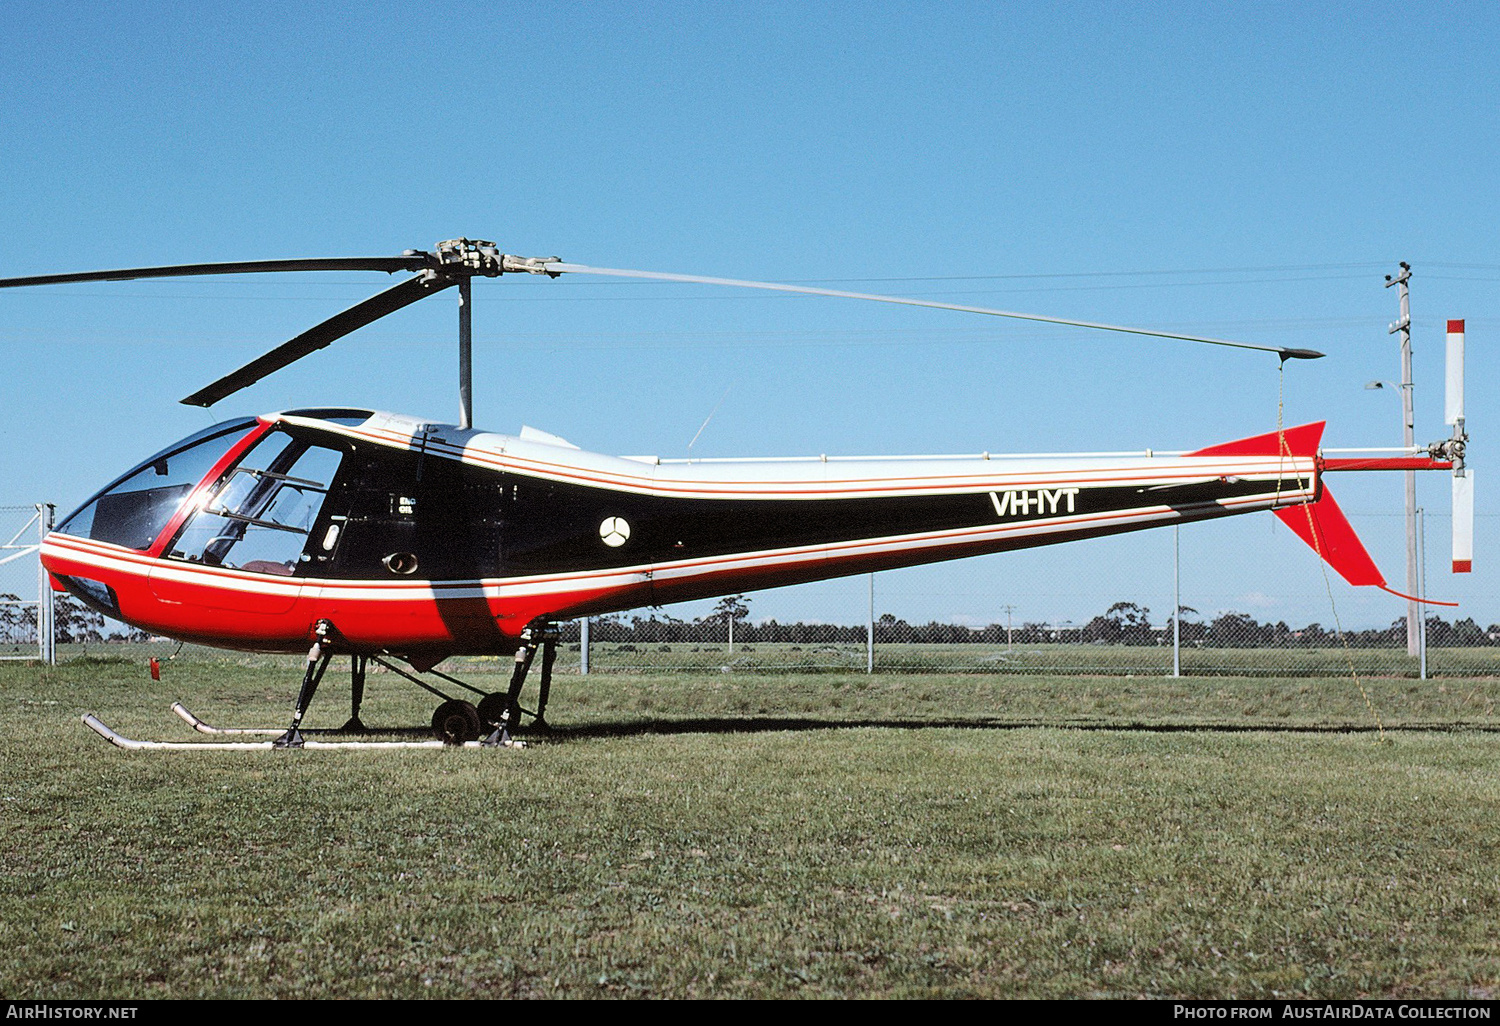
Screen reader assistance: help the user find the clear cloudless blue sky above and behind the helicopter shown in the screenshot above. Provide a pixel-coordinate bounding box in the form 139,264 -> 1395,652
0,3 -> 1500,624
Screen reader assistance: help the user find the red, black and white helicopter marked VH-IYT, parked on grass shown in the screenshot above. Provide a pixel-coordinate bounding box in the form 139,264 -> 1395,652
0,239 -> 1472,747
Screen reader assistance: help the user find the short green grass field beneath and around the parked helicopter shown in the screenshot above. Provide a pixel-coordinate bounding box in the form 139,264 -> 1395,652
0,654 -> 1500,999
